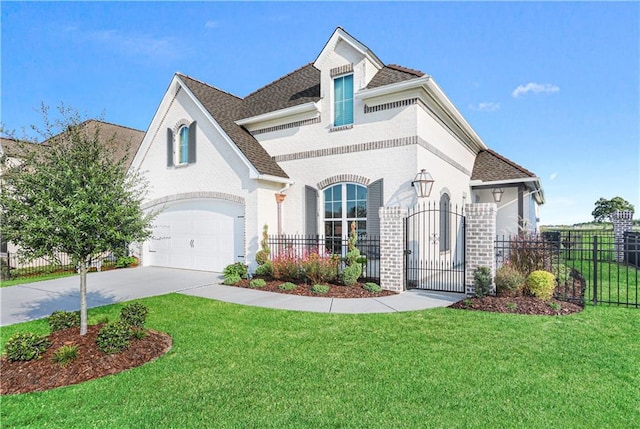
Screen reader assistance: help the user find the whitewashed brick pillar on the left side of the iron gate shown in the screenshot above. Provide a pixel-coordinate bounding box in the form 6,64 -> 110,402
379,207 -> 407,292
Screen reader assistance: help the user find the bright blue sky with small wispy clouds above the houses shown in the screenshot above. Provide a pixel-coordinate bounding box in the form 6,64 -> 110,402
0,1 -> 640,224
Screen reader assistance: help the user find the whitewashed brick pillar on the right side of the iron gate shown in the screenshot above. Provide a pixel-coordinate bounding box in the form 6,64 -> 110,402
464,203 -> 498,295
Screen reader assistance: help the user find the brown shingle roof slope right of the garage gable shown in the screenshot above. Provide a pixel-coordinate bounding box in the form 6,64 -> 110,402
178,74 -> 289,178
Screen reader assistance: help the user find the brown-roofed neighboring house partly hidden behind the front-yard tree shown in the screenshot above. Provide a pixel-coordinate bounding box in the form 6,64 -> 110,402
0,119 -> 144,260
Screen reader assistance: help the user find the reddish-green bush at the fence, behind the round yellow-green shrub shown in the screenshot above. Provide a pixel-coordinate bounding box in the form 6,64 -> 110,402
509,234 -> 554,275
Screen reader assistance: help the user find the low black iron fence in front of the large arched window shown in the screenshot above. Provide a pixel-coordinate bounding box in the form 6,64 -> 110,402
267,235 -> 380,283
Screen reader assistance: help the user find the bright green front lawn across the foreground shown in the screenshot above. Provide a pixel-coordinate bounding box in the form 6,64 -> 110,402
0,294 -> 640,428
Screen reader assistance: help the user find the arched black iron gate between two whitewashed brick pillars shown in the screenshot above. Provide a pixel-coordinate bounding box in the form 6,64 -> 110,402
404,202 -> 466,293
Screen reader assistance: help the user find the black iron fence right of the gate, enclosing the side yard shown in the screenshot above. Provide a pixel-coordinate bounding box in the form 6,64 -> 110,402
495,230 -> 640,308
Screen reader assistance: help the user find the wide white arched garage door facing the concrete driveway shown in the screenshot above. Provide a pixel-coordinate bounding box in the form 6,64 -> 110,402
143,200 -> 244,272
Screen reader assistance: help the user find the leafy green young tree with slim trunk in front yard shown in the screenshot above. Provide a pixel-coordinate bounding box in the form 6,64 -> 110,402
0,106 -> 154,335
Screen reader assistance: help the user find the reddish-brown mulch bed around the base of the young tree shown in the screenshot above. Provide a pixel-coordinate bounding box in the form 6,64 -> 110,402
0,325 -> 172,395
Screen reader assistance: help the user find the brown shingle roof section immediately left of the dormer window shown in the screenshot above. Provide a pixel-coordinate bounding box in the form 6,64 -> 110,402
236,64 -> 320,119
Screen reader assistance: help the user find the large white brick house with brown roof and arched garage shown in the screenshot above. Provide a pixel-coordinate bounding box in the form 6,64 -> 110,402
132,28 -> 544,271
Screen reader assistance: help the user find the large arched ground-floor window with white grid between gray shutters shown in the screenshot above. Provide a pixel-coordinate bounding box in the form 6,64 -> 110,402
324,183 -> 367,254
